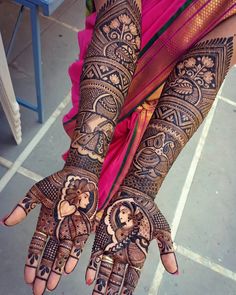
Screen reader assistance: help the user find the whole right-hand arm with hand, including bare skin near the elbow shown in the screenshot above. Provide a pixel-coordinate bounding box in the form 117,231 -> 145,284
86,16 -> 236,295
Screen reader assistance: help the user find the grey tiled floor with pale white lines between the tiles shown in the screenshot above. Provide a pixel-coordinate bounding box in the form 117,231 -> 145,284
0,0 -> 236,295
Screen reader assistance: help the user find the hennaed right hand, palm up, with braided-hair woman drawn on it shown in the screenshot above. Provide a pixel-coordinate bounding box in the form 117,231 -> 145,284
86,187 -> 178,295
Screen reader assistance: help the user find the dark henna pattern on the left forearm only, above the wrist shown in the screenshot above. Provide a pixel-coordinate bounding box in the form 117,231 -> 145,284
66,0 -> 141,175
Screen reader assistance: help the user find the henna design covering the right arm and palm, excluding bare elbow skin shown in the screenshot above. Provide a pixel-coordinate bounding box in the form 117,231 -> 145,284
88,38 -> 233,294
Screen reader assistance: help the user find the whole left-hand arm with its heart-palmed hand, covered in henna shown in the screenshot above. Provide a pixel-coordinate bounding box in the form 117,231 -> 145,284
3,0 -> 141,295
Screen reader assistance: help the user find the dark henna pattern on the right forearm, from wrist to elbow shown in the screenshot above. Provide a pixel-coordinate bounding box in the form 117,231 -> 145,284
124,37 -> 233,198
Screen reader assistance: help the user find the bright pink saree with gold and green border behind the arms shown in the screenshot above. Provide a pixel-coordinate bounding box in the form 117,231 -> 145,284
63,0 -> 236,213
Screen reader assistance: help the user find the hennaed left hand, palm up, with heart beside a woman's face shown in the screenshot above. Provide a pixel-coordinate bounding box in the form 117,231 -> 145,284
3,167 -> 97,295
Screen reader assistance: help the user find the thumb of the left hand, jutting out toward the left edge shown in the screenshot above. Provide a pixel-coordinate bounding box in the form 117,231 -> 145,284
1,186 -> 40,226
